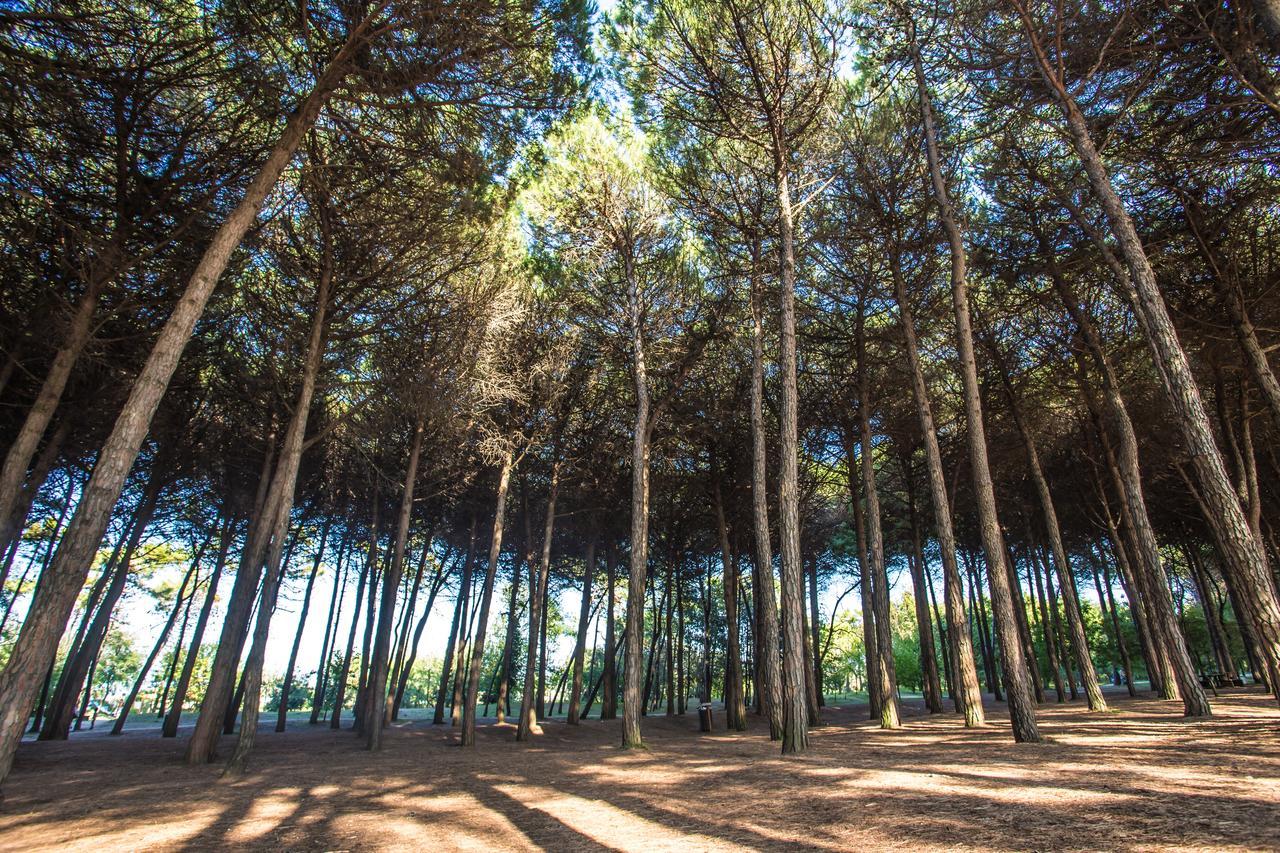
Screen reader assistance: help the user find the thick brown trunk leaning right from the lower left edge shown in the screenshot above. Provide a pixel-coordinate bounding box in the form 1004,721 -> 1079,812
0,16 -> 383,780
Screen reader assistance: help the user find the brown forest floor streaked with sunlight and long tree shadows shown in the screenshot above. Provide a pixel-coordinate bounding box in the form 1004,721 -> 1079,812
0,690 -> 1280,853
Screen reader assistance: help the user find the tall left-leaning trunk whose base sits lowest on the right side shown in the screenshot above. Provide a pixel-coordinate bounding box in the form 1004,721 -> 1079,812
920,39 -> 1041,743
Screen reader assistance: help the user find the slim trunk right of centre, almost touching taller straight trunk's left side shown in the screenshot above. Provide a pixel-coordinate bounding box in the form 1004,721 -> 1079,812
751,264 -> 782,740
